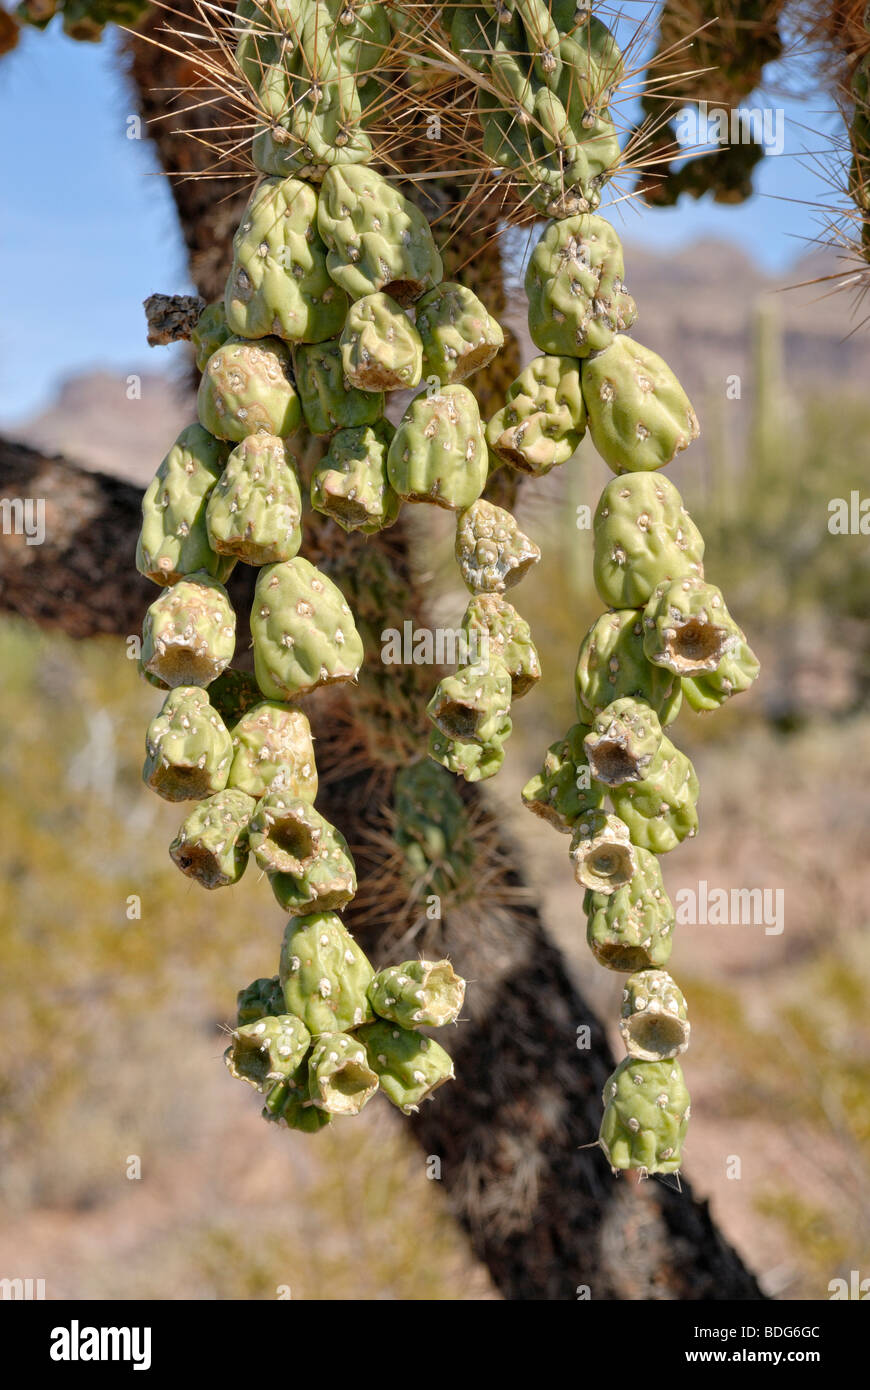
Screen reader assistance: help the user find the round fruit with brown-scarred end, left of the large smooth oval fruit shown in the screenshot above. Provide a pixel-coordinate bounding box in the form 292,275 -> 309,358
142,571 -> 236,688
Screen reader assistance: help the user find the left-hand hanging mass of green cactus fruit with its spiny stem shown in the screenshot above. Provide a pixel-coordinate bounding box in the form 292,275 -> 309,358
129,0 -> 531,1130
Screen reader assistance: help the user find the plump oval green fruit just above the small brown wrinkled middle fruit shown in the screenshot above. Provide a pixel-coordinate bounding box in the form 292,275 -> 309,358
386,386 -> 489,512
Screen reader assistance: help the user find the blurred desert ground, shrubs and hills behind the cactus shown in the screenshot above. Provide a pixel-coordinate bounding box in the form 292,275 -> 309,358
0,227 -> 870,1300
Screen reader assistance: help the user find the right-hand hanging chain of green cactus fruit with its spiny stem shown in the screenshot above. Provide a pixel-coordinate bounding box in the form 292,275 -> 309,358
414,0 -> 757,1175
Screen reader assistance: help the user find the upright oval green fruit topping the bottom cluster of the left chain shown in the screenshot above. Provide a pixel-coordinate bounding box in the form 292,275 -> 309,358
279,912 -> 374,1037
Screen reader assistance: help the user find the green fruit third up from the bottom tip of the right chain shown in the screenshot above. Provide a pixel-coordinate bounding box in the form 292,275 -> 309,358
584,848 -> 675,972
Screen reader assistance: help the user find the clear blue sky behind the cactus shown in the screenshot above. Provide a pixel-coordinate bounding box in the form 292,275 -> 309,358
0,17 -> 835,427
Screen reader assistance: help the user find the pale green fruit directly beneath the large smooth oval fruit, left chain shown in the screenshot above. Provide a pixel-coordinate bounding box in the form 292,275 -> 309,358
228,701 -> 317,803
